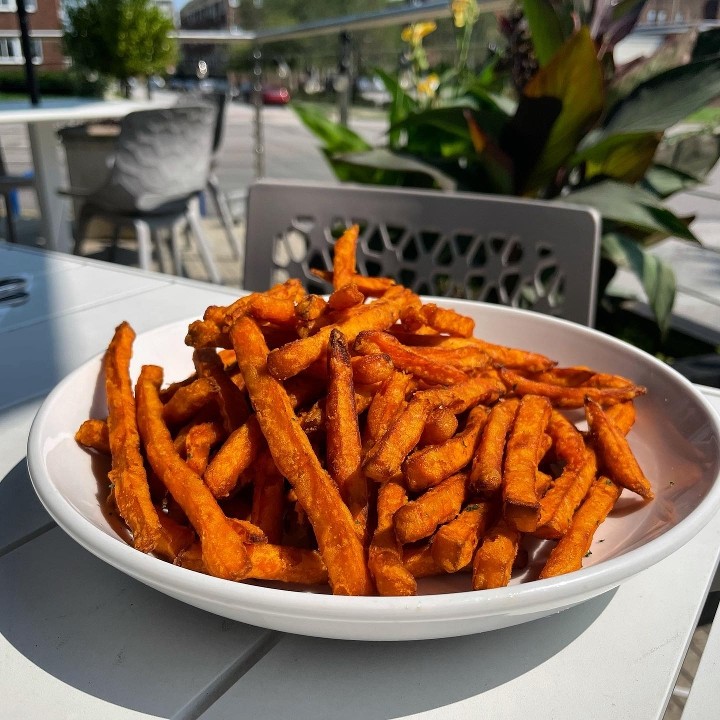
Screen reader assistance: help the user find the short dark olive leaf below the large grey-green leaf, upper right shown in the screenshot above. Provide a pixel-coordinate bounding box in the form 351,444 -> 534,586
570,133 -> 662,184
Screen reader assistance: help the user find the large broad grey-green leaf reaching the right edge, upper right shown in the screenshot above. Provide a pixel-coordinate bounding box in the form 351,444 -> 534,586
603,57 -> 720,135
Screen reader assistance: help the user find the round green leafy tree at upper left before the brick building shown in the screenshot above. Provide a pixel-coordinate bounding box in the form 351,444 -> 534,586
63,0 -> 177,94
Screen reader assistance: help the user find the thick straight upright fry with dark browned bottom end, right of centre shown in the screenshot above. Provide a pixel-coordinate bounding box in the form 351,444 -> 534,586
502,395 -> 552,532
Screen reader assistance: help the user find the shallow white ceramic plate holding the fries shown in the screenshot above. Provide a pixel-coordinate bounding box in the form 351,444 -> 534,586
28,301 -> 720,640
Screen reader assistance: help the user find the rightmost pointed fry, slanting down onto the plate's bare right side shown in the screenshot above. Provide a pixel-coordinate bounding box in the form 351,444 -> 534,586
585,398 -> 654,500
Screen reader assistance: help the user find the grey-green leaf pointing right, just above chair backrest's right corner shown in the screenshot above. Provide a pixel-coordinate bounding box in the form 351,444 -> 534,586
562,180 -> 697,242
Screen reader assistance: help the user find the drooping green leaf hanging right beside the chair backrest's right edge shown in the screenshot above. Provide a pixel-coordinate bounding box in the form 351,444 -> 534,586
602,233 -> 675,334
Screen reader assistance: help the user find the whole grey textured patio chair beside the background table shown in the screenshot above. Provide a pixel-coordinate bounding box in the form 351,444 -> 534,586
61,104 -> 221,283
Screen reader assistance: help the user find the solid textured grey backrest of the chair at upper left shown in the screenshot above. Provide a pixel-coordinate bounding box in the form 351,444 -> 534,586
88,104 -> 216,213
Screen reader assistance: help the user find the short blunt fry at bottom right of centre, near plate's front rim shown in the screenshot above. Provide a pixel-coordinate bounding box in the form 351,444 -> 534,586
430,502 -> 497,573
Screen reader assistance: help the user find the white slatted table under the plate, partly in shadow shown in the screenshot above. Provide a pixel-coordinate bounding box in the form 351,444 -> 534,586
0,247 -> 720,720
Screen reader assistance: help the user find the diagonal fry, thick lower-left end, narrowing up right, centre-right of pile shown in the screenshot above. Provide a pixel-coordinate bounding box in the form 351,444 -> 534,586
405,405 -> 489,492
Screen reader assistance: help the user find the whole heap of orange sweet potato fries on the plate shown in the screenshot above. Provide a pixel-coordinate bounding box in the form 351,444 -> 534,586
76,226 -> 653,595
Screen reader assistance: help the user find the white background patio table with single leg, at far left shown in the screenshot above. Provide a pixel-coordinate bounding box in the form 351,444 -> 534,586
0,96 -> 175,252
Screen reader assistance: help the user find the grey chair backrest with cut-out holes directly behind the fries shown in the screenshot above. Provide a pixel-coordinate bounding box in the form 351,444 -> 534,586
244,181 -> 600,325
